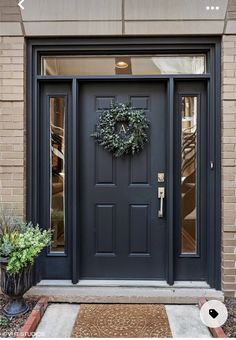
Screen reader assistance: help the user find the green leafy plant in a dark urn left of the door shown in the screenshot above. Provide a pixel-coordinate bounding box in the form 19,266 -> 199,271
0,210 -> 51,316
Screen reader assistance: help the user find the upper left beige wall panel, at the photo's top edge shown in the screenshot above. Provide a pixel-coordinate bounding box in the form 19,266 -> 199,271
21,0 -> 122,21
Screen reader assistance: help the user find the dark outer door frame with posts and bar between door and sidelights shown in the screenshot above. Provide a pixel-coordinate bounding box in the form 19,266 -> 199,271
26,37 -> 221,289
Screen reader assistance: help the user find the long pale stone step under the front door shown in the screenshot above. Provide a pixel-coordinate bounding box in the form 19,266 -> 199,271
27,281 -> 224,304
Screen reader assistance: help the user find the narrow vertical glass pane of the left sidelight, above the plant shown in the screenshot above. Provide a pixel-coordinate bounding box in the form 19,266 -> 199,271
50,97 -> 65,252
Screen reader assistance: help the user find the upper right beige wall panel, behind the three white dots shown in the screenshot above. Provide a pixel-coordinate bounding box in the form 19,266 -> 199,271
125,0 -> 228,20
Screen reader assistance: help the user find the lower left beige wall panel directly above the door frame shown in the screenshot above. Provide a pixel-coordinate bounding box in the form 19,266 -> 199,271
25,21 -> 122,36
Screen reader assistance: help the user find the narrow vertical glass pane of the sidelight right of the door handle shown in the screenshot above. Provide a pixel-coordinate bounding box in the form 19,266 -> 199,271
181,96 -> 198,253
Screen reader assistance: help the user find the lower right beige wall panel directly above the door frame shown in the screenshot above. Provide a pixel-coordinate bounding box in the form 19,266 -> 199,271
125,20 -> 224,35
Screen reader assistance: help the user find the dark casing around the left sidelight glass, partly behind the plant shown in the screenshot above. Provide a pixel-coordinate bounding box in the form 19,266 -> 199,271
35,82 -> 73,281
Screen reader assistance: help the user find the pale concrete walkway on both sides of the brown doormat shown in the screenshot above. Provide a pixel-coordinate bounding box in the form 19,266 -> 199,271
35,303 -> 211,338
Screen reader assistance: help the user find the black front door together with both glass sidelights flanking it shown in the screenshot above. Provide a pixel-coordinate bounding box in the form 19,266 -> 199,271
38,79 -> 210,283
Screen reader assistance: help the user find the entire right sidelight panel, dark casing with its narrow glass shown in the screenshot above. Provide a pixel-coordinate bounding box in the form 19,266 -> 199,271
174,81 -> 208,280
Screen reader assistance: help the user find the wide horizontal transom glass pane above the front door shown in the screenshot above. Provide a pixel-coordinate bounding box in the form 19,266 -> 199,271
41,55 -> 206,76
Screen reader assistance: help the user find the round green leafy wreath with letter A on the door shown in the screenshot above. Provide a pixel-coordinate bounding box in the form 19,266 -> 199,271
92,103 -> 149,157
